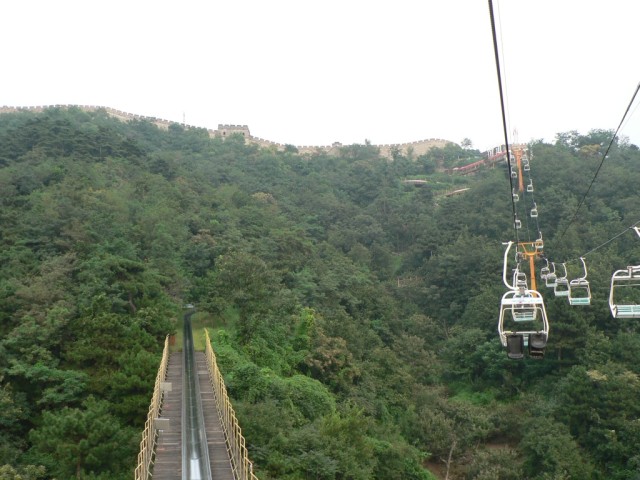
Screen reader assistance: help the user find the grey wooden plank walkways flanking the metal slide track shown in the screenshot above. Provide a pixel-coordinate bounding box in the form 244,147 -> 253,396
153,352 -> 234,480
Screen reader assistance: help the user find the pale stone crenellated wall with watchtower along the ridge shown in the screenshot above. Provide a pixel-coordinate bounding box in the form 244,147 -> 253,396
0,105 -> 452,158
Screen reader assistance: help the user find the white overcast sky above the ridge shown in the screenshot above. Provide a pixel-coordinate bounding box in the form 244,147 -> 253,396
0,0 -> 640,150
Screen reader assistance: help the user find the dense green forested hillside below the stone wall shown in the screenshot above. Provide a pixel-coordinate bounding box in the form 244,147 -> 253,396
0,109 -> 640,480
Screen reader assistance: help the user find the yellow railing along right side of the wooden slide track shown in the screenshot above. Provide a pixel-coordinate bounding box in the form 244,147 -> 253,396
204,328 -> 258,480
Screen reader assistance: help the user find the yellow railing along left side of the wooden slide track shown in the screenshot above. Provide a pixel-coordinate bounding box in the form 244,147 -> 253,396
135,335 -> 169,480
